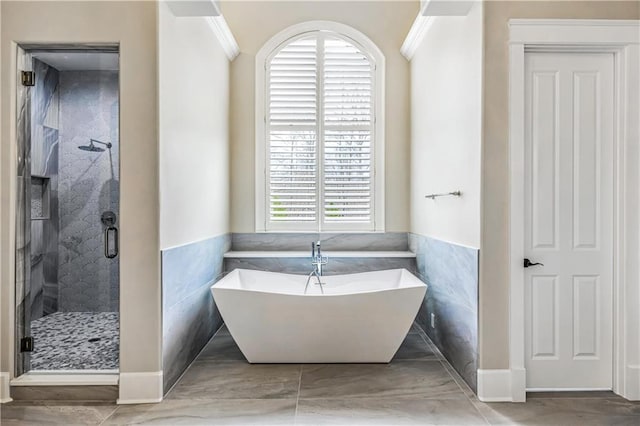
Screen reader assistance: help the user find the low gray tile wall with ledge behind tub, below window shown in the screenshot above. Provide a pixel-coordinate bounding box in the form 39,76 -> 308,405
224,232 -> 416,275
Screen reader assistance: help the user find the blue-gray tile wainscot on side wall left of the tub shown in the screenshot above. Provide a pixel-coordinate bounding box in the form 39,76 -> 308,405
162,234 -> 231,393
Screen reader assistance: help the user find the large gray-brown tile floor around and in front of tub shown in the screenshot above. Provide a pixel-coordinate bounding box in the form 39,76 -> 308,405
0,327 -> 640,426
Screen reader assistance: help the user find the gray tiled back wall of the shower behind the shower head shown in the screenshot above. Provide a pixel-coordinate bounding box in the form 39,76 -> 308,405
58,71 -> 119,312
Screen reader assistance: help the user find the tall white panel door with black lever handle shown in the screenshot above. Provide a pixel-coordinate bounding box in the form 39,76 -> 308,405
524,52 -> 614,390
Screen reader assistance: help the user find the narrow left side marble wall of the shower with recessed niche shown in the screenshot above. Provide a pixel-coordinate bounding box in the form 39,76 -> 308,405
29,59 -> 60,320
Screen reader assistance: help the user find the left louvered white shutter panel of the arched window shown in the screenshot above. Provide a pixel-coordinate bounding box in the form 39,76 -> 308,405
268,37 -> 318,223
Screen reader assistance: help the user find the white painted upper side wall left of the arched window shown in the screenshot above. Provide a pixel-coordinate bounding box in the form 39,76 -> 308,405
158,3 -> 229,249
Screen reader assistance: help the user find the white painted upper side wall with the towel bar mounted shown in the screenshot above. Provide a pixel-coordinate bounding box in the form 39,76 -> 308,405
411,2 -> 482,248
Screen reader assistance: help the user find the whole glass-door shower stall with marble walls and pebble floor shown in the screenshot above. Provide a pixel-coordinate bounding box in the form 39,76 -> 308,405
15,46 -> 120,376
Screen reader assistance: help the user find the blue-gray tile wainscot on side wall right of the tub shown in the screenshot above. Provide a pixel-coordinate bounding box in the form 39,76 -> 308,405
409,234 -> 479,392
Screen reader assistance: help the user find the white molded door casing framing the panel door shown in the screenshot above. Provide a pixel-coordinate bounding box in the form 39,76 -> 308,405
509,19 -> 640,402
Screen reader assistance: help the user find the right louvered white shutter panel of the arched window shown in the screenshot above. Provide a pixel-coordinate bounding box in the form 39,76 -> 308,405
323,37 -> 373,223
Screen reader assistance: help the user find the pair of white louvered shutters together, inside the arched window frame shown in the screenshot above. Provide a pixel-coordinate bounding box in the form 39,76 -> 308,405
266,32 -> 375,230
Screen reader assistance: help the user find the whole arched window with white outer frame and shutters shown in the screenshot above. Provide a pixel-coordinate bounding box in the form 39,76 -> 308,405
256,22 -> 384,231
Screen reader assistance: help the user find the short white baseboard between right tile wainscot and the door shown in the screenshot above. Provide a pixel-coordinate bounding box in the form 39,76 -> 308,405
478,369 -> 526,402
